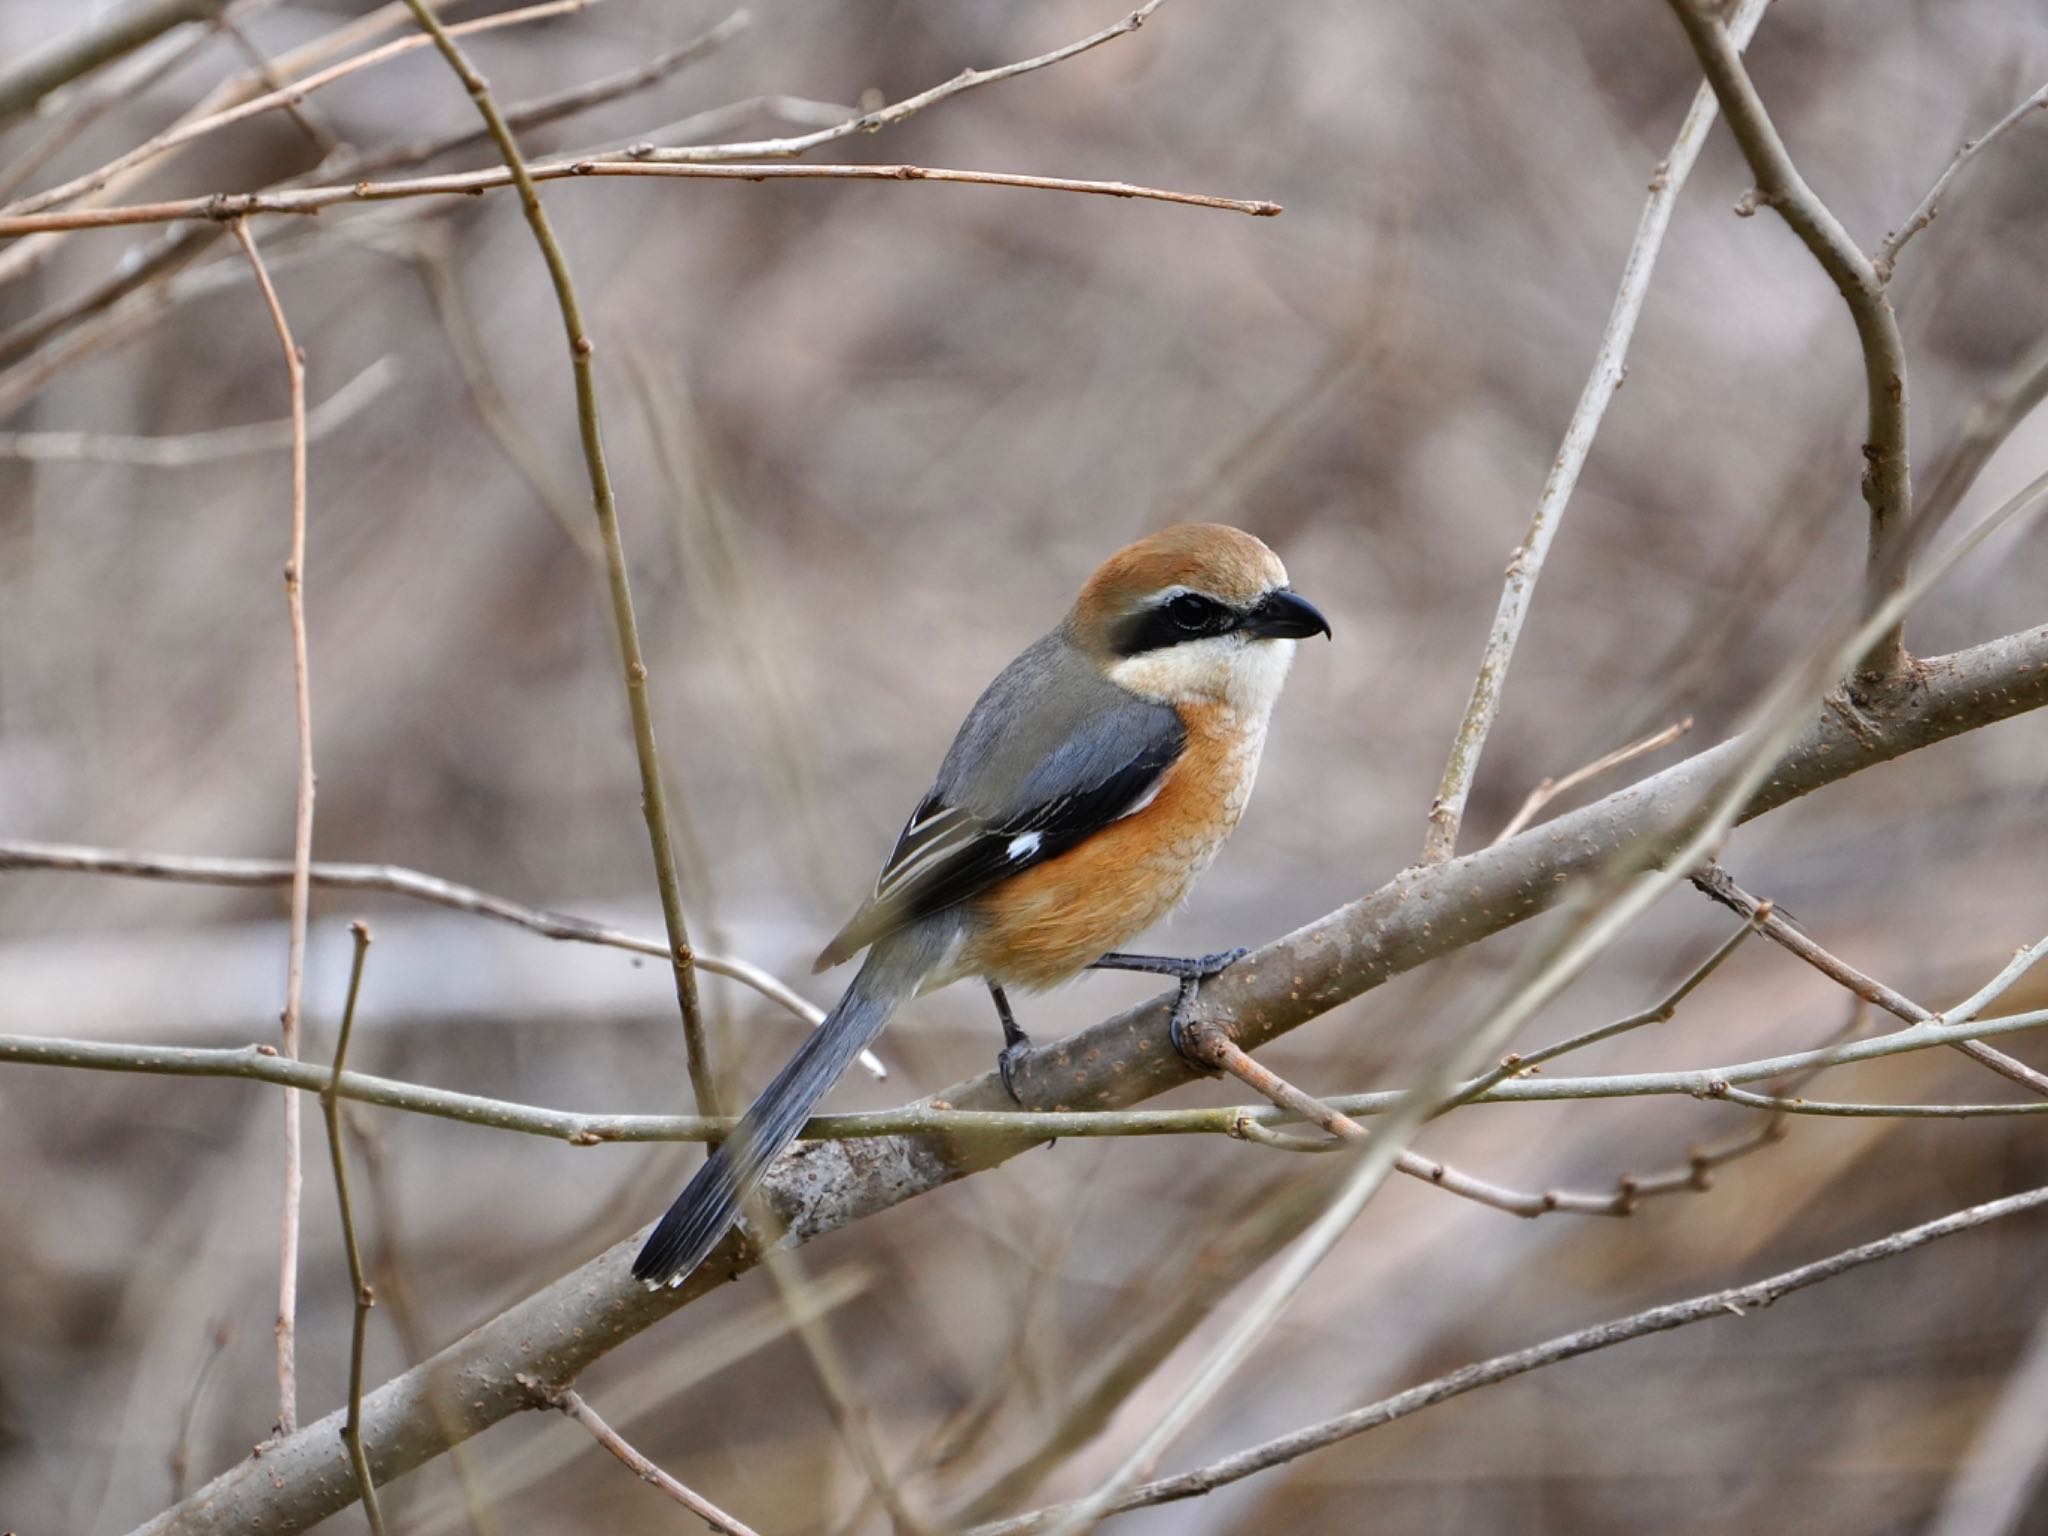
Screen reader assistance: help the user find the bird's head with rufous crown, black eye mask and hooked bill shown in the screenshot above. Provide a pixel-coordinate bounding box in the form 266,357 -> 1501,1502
1067,522 -> 1329,715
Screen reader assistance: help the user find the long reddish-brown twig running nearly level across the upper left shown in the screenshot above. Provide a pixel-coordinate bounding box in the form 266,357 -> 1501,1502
0,160 -> 1282,240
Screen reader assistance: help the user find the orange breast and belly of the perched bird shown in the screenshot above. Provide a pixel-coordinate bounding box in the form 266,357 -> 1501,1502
958,705 -> 1266,989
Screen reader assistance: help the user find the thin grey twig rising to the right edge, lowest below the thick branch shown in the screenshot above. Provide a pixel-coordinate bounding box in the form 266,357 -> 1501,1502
969,1190 -> 2048,1536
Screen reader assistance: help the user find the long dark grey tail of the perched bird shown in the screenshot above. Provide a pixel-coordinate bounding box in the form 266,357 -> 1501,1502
633,934 -> 928,1286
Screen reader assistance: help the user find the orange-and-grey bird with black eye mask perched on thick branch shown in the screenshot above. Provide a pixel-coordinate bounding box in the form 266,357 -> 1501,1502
633,522 -> 1331,1290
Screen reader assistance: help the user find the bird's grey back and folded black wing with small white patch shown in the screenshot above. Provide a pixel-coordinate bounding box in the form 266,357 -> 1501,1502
802,635 -> 1186,969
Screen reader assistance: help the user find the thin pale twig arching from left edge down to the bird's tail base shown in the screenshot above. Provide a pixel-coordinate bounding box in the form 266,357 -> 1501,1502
0,840 -> 889,1081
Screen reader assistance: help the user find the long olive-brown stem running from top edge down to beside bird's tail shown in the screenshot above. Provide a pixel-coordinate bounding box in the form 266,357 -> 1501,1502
406,0 -> 719,1114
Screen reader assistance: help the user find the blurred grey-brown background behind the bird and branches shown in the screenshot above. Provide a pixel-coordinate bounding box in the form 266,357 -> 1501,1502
0,0 -> 2048,1536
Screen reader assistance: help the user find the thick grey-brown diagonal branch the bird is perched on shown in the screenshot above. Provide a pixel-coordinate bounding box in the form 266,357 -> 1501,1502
128,625 -> 2048,1536
